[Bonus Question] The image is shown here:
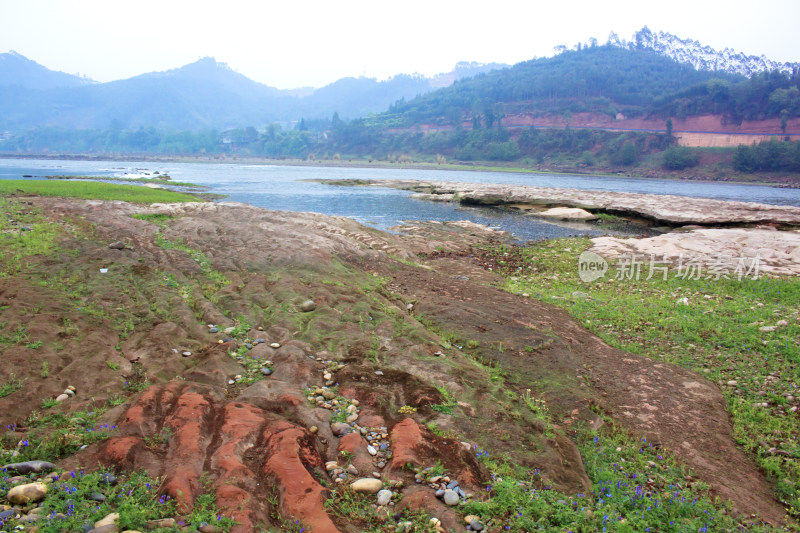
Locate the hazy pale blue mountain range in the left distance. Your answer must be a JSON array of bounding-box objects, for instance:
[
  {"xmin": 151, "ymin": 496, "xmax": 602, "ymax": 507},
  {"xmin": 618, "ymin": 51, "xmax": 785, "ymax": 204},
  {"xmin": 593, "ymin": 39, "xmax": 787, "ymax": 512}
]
[{"xmin": 0, "ymin": 52, "xmax": 510, "ymax": 131}]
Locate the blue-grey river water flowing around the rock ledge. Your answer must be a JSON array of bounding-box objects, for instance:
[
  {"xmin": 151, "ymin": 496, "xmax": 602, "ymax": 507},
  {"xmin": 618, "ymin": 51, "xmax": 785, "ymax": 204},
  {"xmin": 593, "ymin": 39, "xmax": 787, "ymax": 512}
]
[{"xmin": 0, "ymin": 159, "xmax": 800, "ymax": 240}]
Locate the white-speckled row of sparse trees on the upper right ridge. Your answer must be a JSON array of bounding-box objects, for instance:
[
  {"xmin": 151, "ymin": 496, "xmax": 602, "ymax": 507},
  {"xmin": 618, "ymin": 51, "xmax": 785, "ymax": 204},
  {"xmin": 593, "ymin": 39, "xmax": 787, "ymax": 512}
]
[{"xmin": 608, "ymin": 26, "xmax": 800, "ymax": 78}]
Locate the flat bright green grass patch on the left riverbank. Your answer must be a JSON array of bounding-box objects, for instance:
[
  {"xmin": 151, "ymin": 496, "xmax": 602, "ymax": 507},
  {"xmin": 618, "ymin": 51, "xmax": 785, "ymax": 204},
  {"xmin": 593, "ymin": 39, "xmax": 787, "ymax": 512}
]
[{"xmin": 0, "ymin": 180, "xmax": 199, "ymax": 204}]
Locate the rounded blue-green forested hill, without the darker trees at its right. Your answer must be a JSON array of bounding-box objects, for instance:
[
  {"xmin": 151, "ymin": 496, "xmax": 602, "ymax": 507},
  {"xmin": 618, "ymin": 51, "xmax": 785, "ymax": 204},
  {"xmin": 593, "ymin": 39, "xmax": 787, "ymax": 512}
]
[{"xmin": 382, "ymin": 45, "xmax": 746, "ymax": 126}]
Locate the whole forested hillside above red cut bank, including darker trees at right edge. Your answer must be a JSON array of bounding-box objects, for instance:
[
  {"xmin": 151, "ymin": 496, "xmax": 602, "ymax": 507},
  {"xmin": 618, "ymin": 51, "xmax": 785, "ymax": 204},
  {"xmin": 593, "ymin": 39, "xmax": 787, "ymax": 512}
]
[{"xmin": 373, "ymin": 45, "xmax": 800, "ymax": 127}]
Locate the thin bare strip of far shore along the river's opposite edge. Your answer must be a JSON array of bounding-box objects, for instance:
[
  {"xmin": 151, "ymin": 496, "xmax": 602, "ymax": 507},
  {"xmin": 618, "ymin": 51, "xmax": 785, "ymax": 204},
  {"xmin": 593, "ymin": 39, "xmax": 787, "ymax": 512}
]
[{"xmin": 0, "ymin": 153, "xmax": 800, "ymax": 189}]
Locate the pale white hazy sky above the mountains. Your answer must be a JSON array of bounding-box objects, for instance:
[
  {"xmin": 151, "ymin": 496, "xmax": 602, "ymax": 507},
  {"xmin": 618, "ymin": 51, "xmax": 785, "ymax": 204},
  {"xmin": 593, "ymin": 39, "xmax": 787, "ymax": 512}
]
[{"xmin": 0, "ymin": 0, "xmax": 800, "ymax": 88}]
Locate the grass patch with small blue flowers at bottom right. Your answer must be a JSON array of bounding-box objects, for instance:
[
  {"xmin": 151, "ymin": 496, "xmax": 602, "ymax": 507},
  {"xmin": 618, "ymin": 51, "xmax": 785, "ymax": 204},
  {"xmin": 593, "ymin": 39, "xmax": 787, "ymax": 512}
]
[{"xmin": 459, "ymin": 426, "xmax": 768, "ymax": 533}]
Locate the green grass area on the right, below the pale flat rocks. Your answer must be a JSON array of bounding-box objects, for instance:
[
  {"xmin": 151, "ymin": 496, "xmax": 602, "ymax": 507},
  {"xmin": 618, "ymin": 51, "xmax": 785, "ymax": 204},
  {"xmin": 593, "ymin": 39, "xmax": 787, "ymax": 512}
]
[{"xmin": 482, "ymin": 239, "xmax": 800, "ymax": 516}]
